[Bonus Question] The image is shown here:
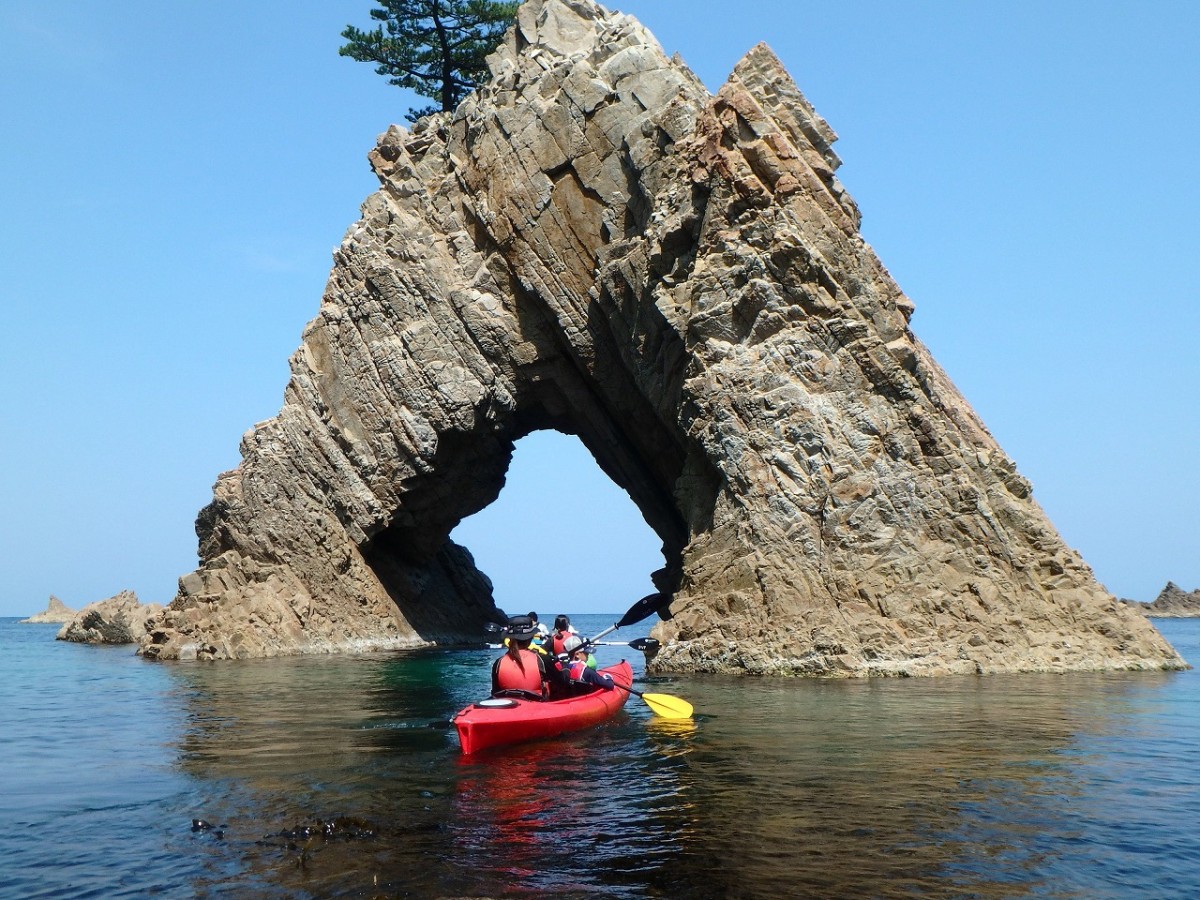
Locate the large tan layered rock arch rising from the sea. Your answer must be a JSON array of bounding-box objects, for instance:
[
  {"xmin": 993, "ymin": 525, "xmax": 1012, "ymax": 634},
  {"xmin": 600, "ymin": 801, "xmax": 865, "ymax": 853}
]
[{"xmin": 133, "ymin": 0, "xmax": 1184, "ymax": 676}]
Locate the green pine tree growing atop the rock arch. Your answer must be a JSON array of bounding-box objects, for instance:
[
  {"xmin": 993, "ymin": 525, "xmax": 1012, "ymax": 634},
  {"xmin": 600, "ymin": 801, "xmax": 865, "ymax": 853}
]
[{"xmin": 338, "ymin": 0, "xmax": 520, "ymax": 122}]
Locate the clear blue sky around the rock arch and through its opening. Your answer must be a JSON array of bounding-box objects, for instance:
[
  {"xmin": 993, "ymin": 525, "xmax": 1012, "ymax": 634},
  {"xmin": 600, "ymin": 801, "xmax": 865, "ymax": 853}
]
[{"xmin": 0, "ymin": 0, "xmax": 1200, "ymax": 616}]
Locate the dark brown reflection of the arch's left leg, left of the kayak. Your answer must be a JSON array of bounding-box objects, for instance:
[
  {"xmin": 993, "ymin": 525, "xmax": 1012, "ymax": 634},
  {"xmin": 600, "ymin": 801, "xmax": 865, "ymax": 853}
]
[{"xmin": 172, "ymin": 652, "xmax": 468, "ymax": 896}]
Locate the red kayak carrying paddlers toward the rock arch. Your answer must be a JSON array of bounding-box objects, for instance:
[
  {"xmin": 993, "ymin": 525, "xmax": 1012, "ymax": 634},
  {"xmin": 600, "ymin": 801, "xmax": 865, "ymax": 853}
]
[{"xmin": 454, "ymin": 660, "xmax": 634, "ymax": 754}]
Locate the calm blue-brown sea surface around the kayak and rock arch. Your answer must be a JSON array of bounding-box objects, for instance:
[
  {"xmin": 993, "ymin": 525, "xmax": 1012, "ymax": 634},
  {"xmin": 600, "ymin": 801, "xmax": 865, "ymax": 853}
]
[{"xmin": 0, "ymin": 612, "xmax": 1200, "ymax": 899}]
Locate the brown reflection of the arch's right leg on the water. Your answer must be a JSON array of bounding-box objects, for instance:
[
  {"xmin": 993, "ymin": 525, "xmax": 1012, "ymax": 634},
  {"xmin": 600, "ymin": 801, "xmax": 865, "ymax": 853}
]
[{"xmin": 633, "ymin": 673, "xmax": 1171, "ymax": 896}]
